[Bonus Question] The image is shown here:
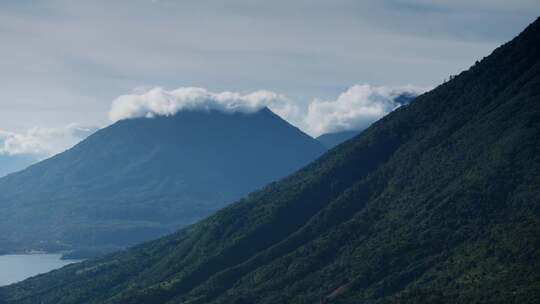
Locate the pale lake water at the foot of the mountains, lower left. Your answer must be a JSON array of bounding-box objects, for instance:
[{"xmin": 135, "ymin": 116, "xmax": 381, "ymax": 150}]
[{"xmin": 0, "ymin": 253, "xmax": 77, "ymax": 286}]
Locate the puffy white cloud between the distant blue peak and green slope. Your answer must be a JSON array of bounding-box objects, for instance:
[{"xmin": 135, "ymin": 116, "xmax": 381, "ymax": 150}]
[{"xmin": 305, "ymin": 84, "xmax": 425, "ymax": 136}]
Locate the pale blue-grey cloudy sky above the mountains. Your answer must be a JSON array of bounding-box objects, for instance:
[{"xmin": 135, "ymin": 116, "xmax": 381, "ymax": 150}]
[{"xmin": 0, "ymin": 0, "xmax": 540, "ymax": 155}]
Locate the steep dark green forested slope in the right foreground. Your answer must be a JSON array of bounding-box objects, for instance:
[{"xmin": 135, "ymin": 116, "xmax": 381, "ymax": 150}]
[{"xmin": 0, "ymin": 20, "xmax": 540, "ymax": 304}]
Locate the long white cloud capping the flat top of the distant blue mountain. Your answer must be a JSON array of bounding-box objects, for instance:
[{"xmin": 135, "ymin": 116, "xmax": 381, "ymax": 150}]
[{"xmin": 109, "ymin": 87, "xmax": 295, "ymax": 122}]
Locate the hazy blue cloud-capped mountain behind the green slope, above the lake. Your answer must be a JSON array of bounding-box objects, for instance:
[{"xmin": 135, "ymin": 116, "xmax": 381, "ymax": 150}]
[{"xmin": 0, "ymin": 108, "xmax": 325, "ymax": 251}]
